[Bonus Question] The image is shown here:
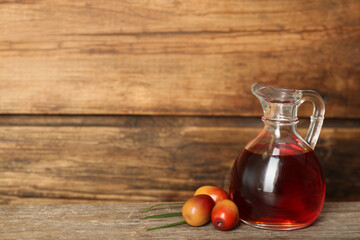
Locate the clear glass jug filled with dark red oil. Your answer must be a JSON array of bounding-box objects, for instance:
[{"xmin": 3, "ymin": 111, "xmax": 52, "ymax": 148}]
[{"xmin": 229, "ymin": 83, "xmax": 325, "ymax": 230}]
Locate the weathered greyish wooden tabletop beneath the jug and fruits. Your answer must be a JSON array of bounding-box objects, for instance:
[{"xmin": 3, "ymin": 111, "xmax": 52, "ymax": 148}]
[{"xmin": 0, "ymin": 202, "xmax": 360, "ymax": 239}]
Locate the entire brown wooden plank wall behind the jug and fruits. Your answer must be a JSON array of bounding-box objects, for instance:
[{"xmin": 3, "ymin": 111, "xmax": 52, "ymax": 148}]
[{"xmin": 0, "ymin": 0, "xmax": 360, "ymax": 204}]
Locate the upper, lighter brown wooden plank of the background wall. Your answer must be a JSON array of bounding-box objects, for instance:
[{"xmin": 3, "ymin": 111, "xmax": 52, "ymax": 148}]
[{"xmin": 0, "ymin": 0, "xmax": 360, "ymax": 118}]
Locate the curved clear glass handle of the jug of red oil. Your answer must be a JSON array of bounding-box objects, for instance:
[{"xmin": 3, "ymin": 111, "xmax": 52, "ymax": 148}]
[{"xmin": 300, "ymin": 90, "xmax": 325, "ymax": 149}]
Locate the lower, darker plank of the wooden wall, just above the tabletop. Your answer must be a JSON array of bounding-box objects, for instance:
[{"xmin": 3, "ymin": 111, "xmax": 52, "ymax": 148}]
[{"xmin": 0, "ymin": 116, "xmax": 360, "ymax": 204}]
